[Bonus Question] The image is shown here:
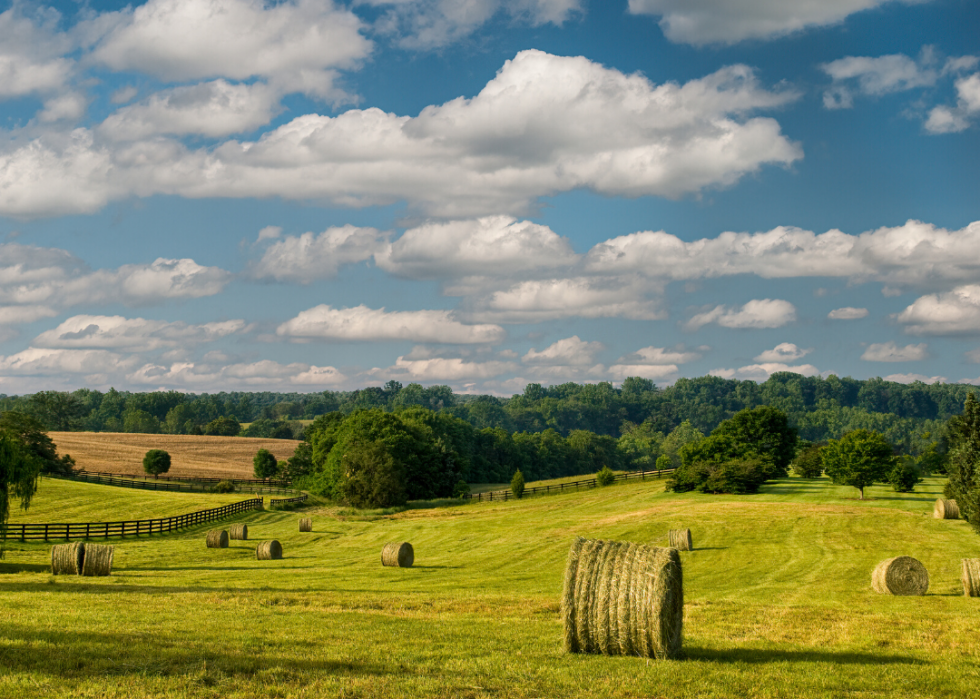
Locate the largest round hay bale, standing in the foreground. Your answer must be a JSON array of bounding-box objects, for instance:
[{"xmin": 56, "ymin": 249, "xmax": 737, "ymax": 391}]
[{"xmin": 561, "ymin": 537, "xmax": 684, "ymax": 658}]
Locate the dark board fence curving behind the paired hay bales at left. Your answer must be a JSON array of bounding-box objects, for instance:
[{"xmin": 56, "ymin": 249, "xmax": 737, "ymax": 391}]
[{"xmin": 4, "ymin": 498, "xmax": 262, "ymax": 541}]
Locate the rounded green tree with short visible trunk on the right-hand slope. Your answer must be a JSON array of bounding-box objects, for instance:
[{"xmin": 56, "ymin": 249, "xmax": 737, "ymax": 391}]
[{"xmin": 820, "ymin": 430, "xmax": 898, "ymax": 500}]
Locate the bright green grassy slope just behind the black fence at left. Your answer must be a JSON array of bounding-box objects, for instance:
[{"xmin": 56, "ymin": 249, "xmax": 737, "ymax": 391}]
[{"xmin": 10, "ymin": 478, "xmax": 249, "ymax": 524}]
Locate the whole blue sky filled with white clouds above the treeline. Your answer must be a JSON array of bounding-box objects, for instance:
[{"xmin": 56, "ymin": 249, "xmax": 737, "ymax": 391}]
[{"xmin": 0, "ymin": 0, "xmax": 980, "ymax": 395}]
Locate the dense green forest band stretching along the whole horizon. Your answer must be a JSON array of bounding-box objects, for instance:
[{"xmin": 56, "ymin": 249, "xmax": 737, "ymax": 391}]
[{"xmin": 0, "ymin": 373, "xmax": 978, "ymax": 452}]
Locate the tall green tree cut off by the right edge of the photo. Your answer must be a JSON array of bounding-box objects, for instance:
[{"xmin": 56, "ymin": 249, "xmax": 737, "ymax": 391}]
[{"xmin": 944, "ymin": 393, "xmax": 980, "ymax": 531}]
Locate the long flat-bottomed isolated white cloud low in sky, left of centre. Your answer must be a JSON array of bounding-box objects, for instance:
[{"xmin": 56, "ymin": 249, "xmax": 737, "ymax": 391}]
[{"xmin": 276, "ymin": 304, "xmax": 506, "ymax": 344}]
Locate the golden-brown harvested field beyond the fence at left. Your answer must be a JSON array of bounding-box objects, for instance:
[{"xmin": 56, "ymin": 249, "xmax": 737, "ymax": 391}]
[{"xmin": 48, "ymin": 432, "xmax": 299, "ymax": 478}]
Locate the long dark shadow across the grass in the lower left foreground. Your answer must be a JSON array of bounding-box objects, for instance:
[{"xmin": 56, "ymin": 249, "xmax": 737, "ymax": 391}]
[{"xmin": 3, "ymin": 625, "xmax": 394, "ymax": 680}]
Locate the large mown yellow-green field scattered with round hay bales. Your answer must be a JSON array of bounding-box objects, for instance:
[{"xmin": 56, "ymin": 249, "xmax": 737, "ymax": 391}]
[{"xmin": 0, "ymin": 478, "xmax": 980, "ymax": 698}]
